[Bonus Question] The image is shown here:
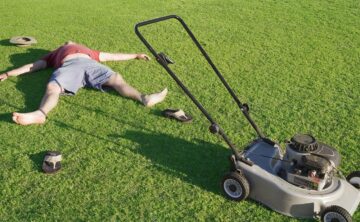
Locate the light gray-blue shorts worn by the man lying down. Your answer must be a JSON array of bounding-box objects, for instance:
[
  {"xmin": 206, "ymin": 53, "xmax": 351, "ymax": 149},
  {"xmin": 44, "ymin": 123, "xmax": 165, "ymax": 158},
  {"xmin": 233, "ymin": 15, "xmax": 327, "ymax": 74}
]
[{"xmin": 49, "ymin": 58, "xmax": 115, "ymax": 94}]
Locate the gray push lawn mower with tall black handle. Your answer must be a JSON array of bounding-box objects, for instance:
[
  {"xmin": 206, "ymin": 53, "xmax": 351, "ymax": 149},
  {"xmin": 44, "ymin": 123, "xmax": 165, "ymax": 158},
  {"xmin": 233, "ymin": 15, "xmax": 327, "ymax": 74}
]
[{"xmin": 135, "ymin": 15, "xmax": 360, "ymax": 222}]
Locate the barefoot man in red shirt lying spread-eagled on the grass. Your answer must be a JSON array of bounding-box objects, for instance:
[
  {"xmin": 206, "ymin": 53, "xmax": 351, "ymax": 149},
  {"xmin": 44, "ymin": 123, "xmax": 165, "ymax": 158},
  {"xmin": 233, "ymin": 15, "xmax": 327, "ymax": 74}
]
[{"xmin": 0, "ymin": 41, "xmax": 167, "ymax": 125}]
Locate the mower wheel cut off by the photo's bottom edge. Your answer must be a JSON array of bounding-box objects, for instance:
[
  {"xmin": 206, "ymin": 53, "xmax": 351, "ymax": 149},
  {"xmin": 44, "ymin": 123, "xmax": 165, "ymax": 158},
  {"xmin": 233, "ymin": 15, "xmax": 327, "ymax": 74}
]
[{"xmin": 321, "ymin": 206, "xmax": 352, "ymax": 222}]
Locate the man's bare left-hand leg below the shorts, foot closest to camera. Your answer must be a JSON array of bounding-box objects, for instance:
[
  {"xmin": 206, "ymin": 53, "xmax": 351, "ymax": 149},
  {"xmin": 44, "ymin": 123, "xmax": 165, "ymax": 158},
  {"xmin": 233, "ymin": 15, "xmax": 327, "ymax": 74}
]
[{"xmin": 12, "ymin": 81, "xmax": 63, "ymax": 125}]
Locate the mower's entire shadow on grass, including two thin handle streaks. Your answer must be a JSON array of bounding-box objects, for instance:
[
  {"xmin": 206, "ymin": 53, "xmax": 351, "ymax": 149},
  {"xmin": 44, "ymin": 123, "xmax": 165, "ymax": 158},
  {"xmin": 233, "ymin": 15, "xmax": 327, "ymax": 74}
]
[{"xmin": 50, "ymin": 93, "xmax": 230, "ymax": 195}]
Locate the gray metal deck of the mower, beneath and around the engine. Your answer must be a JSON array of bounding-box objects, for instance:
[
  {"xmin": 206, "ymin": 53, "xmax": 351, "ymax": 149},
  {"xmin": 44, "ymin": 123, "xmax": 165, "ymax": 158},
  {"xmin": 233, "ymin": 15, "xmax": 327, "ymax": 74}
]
[{"xmin": 236, "ymin": 140, "xmax": 360, "ymax": 218}]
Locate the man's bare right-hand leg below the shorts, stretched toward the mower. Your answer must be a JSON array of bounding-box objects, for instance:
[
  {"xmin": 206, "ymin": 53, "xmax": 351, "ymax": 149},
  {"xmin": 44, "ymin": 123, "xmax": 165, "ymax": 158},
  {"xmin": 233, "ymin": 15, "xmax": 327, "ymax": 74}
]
[{"xmin": 104, "ymin": 73, "xmax": 168, "ymax": 107}]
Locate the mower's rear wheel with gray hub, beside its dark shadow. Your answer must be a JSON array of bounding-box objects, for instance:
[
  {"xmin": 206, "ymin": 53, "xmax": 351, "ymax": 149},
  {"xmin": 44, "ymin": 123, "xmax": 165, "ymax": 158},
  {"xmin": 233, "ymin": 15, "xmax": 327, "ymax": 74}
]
[{"xmin": 222, "ymin": 171, "xmax": 250, "ymax": 201}]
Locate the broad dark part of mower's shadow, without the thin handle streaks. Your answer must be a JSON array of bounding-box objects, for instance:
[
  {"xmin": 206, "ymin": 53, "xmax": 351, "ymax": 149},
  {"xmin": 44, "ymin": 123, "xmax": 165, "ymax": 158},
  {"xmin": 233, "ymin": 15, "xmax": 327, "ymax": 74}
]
[{"xmin": 122, "ymin": 131, "xmax": 230, "ymax": 194}]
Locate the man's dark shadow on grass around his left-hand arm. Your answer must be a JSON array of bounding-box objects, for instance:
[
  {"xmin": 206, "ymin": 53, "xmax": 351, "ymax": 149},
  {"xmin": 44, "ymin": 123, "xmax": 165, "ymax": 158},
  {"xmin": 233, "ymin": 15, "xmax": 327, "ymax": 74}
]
[{"xmin": 4, "ymin": 48, "xmax": 52, "ymax": 112}]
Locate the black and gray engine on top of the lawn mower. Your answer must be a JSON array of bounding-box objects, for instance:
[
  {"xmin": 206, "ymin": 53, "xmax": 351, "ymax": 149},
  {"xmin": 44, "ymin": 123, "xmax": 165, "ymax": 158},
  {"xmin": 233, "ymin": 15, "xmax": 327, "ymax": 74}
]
[{"xmin": 282, "ymin": 134, "xmax": 340, "ymax": 191}]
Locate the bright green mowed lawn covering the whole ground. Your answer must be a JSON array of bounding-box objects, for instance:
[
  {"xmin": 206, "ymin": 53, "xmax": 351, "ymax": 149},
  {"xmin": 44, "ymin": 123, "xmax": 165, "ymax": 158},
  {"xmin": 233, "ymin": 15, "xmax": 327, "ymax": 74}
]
[{"xmin": 0, "ymin": 0, "xmax": 360, "ymax": 221}]
